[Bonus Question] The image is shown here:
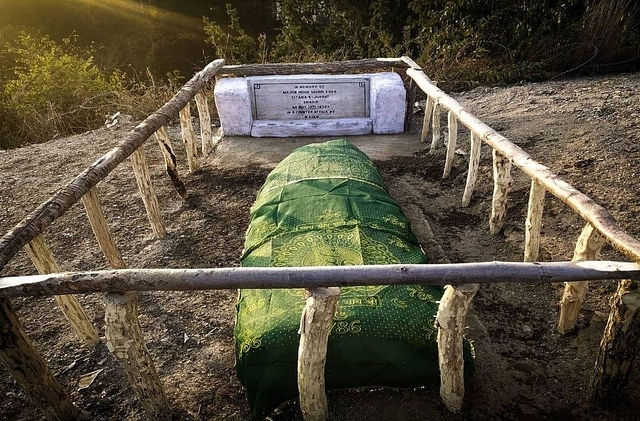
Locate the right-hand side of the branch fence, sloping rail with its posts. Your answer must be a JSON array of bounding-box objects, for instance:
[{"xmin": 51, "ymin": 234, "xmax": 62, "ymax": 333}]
[{"xmin": 406, "ymin": 66, "xmax": 640, "ymax": 410}]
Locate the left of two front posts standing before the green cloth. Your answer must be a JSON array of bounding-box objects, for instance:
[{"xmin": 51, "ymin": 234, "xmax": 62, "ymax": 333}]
[{"xmin": 298, "ymin": 287, "xmax": 340, "ymax": 421}]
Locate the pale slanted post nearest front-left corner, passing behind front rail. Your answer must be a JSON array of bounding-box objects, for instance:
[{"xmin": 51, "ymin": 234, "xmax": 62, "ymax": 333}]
[{"xmin": 24, "ymin": 234, "xmax": 100, "ymax": 346}]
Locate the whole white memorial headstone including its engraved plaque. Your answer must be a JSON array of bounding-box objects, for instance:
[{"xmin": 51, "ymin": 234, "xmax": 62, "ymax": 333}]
[{"xmin": 214, "ymin": 72, "xmax": 406, "ymax": 137}]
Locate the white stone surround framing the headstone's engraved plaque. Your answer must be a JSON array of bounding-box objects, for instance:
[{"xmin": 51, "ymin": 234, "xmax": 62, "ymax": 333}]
[{"xmin": 214, "ymin": 72, "xmax": 406, "ymax": 137}]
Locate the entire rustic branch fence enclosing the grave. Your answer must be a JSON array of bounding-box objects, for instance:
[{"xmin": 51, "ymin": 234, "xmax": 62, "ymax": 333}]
[{"xmin": 0, "ymin": 57, "xmax": 640, "ymax": 420}]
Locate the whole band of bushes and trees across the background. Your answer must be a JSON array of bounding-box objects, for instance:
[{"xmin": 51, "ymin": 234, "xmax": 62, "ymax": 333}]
[{"xmin": 0, "ymin": 0, "xmax": 640, "ymax": 148}]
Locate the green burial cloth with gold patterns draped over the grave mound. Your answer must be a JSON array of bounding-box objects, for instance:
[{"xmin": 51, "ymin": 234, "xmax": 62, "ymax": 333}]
[{"xmin": 235, "ymin": 139, "xmax": 472, "ymax": 418}]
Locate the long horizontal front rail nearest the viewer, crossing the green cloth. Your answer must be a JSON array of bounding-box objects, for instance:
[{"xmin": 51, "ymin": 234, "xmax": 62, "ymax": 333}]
[{"xmin": 0, "ymin": 261, "xmax": 640, "ymax": 297}]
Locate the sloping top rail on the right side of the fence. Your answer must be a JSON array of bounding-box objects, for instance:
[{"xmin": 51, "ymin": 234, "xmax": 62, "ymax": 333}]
[{"xmin": 407, "ymin": 69, "xmax": 640, "ymax": 262}]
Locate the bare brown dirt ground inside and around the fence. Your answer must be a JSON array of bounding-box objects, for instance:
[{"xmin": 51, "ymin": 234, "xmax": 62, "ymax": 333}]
[{"xmin": 0, "ymin": 74, "xmax": 640, "ymax": 421}]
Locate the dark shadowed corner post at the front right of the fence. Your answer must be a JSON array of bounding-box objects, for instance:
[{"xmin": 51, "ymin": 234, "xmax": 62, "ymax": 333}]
[{"xmin": 589, "ymin": 280, "xmax": 640, "ymax": 406}]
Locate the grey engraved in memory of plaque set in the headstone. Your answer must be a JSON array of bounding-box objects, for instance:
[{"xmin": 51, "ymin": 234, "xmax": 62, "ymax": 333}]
[{"xmin": 249, "ymin": 77, "xmax": 369, "ymax": 120}]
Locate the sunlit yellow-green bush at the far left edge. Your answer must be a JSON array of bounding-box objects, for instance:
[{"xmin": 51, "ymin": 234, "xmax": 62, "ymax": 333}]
[{"xmin": 0, "ymin": 32, "xmax": 123, "ymax": 147}]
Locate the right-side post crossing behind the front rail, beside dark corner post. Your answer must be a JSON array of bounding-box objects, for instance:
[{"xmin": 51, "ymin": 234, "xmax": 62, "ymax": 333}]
[{"xmin": 558, "ymin": 224, "xmax": 605, "ymax": 334}]
